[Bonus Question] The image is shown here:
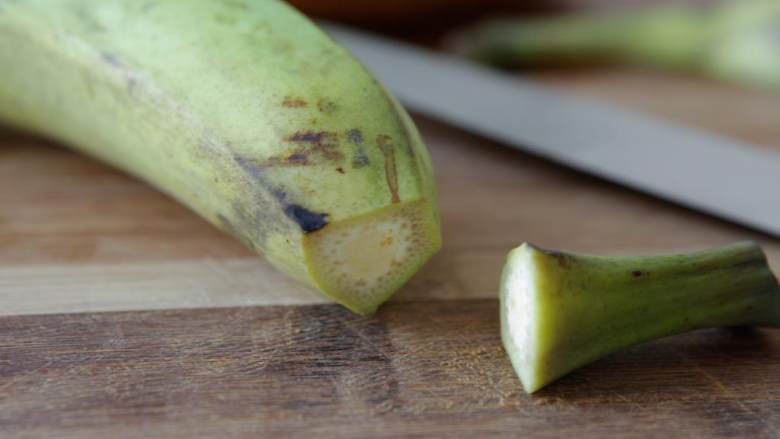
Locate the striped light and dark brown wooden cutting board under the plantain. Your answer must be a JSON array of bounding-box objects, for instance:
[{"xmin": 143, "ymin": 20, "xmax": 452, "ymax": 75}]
[{"xmin": 0, "ymin": 72, "xmax": 780, "ymax": 438}]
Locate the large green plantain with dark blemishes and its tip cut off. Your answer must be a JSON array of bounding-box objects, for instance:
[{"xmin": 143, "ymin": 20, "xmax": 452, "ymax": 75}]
[{"xmin": 0, "ymin": 0, "xmax": 441, "ymax": 314}]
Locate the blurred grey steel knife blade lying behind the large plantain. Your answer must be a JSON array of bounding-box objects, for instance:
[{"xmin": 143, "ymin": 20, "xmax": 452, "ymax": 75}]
[{"xmin": 323, "ymin": 23, "xmax": 780, "ymax": 236}]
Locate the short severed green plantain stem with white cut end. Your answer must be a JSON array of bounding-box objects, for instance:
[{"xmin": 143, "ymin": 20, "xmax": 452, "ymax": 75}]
[{"xmin": 501, "ymin": 242, "xmax": 780, "ymax": 393}]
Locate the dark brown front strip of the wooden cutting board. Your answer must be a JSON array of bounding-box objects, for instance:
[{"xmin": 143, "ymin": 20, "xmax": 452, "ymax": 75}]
[{"xmin": 0, "ymin": 300, "xmax": 780, "ymax": 439}]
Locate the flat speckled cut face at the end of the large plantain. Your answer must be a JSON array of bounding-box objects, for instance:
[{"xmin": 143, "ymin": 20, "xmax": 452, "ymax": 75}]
[{"xmin": 305, "ymin": 200, "xmax": 441, "ymax": 314}]
